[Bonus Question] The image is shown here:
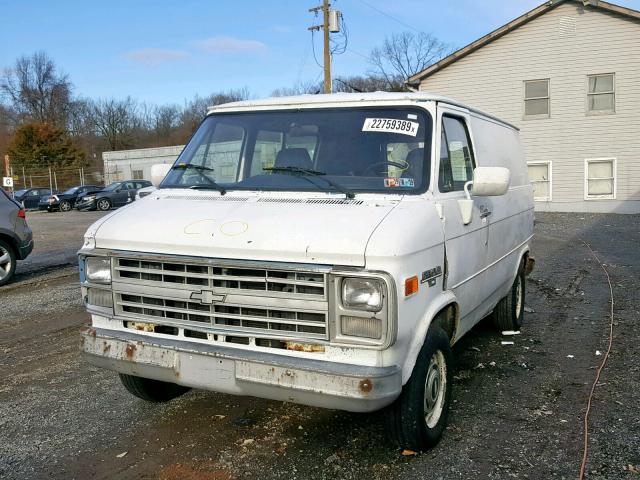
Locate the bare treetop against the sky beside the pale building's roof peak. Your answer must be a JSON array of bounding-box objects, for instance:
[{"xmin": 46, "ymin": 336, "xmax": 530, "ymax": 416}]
[{"xmin": 369, "ymin": 32, "xmax": 451, "ymax": 91}]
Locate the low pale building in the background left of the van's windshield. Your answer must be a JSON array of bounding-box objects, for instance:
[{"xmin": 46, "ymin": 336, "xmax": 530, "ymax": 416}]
[{"xmin": 102, "ymin": 145, "xmax": 184, "ymax": 185}]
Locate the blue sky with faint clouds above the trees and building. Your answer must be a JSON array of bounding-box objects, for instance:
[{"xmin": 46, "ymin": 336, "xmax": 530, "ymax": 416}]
[{"xmin": 0, "ymin": 0, "xmax": 640, "ymax": 104}]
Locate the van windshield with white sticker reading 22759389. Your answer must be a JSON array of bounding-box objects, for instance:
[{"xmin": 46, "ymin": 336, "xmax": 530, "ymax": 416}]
[{"xmin": 161, "ymin": 107, "xmax": 431, "ymax": 194}]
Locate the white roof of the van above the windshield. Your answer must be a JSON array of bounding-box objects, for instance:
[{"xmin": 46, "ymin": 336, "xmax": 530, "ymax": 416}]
[{"xmin": 207, "ymin": 92, "xmax": 519, "ymax": 130}]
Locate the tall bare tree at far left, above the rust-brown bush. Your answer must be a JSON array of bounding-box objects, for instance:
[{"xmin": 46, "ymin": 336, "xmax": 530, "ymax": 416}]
[{"xmin": 0, "ymin": 51, "xmax": 72, "ymax": 128}]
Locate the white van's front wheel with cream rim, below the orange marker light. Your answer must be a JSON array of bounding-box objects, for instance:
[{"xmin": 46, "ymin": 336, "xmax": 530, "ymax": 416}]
[{"xmin": 385, "ymin": 326, "xmax": 453, "ymax": 451}]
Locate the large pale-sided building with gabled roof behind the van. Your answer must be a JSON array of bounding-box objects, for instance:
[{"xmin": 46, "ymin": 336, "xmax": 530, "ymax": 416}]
[{"xmin": 408, "ymin": 0, "xmax": 640, "ymax": 213}]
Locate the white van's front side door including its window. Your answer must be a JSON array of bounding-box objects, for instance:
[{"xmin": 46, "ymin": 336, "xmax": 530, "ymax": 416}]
[{"xmin": 434, "ymin": 104, "xmax": 490, "ymax": 337}]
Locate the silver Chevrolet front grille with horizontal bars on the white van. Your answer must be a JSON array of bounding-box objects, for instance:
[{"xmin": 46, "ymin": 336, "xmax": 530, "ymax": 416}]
[{"xmin": 113, "ymin": 258, "xmax": 329, "ymax": 346}]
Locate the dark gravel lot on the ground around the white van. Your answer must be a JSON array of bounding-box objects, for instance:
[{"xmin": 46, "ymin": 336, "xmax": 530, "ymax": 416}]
[{"xmin": 0, "ymin": 212, "xmax": 640, "ymax": 480}]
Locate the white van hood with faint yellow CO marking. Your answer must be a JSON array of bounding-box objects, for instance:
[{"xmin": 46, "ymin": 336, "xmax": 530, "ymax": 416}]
[{"xmin": 87, "ymin": 192, "xmax": 399, "ymax": 267}]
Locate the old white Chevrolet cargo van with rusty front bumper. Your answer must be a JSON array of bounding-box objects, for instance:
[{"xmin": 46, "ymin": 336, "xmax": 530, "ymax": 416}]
[{"xmin": 79, "ymin": 93, "xmax": 533, "ymax": 450}]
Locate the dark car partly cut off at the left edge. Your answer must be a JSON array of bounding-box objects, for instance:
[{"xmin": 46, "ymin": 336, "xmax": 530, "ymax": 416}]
[{"xmin": 0, "ymin": 189, "xmax": 33, "ymax": 285}]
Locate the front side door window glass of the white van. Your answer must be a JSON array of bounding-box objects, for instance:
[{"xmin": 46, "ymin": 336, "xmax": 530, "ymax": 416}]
[{"xmin": 438, "ymin": 117, "xmax": 475, "ymax": 192}]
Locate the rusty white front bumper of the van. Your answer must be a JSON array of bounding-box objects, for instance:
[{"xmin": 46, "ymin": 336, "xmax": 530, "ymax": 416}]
[{"xmin": 81, "ymin": 327, "xmax": 402, "ymax": 412}]
